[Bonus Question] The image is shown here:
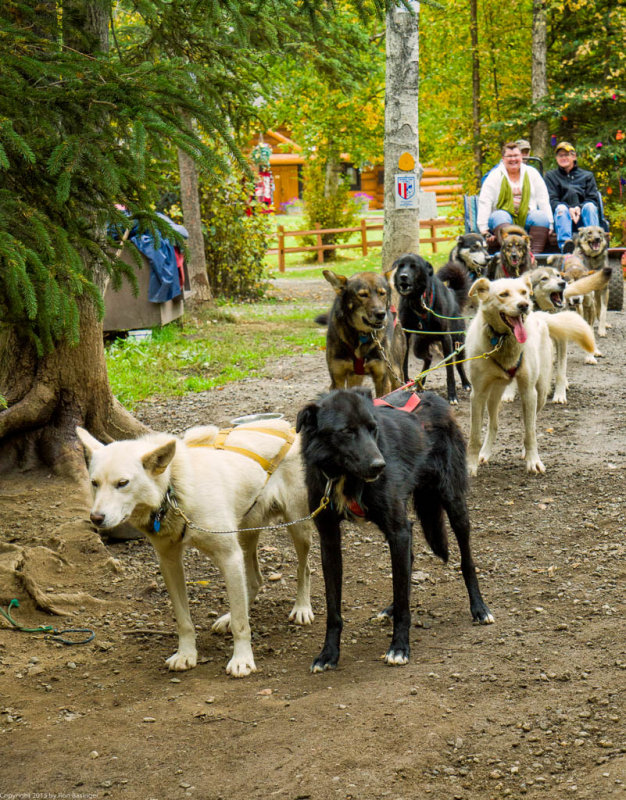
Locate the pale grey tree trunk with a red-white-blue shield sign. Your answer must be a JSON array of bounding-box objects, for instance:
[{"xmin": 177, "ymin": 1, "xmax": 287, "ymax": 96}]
[{"xmin": 382, "ymin": 3, "xmax": 422, "ymax": 272}]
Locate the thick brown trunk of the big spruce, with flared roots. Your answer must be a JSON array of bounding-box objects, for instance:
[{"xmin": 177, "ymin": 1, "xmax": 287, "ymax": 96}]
[{"xmin": 0, "ymin": 0, "xmax": 146, "ymax": 477}]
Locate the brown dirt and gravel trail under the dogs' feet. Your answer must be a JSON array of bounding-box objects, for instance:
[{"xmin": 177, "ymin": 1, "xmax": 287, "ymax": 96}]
[{"xmin": 0, "ymin": 287, "xmax": 626, "ymax": 800}]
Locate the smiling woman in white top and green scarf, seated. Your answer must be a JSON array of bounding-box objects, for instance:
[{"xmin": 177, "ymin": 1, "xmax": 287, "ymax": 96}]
[{"xmin": 477, "ymin": 142, "xmax": 554, "ymax": 253}]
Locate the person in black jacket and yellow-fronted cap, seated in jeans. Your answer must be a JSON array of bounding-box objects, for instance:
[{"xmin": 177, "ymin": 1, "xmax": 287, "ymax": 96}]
[{"xmin": 545, "ymin": 142, "xmax": 600, "ymax": 253}]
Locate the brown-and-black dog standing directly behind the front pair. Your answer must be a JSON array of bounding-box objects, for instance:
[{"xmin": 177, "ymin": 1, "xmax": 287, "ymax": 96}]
[{"xmin": 318, "ymin": 269, "xmax": 406, "ymax": 397}]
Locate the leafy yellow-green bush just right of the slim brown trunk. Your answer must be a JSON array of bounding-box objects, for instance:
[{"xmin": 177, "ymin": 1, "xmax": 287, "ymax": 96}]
[{"xmin": 200, "ymin": 172, "xmax": 270, "ymax": 300}]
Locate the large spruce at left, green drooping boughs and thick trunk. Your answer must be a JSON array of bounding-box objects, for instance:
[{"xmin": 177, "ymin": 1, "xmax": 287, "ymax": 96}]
[{"xmin": 0, "ymin": 0, "xmax": 388, "ymax": 474}]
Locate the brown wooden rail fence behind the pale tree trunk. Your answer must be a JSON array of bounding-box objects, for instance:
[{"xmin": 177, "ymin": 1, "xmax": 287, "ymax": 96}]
[{"xmin": 266, "ymin": 218, "xmax": 460, "ymax": 272}]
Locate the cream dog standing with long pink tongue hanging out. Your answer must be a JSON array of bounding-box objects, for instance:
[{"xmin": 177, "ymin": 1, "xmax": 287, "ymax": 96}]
[{"xmin": 466, "ymin": 274, "xmax": 593, "ymax": 475}]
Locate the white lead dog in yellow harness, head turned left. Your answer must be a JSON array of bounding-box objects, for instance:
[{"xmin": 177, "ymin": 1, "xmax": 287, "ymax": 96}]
[{"xmin": 76, "ymin": 420, "xmax": 313, "ymax": 677}]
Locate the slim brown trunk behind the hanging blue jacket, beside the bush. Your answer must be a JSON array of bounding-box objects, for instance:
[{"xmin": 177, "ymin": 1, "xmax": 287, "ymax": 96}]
[{"xmin": 178, "ymin": 142, "xmax": 213, "ymax": 302}]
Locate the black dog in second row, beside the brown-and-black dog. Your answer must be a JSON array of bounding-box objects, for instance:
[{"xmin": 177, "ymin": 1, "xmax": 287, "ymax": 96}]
[{"xmin": 393, "ymin": 253, "xmax": 470, "ymax": 405}]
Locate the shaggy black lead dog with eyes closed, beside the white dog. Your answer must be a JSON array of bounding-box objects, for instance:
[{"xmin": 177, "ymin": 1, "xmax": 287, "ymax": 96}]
[{"xmin": 296, "ymin": 389, "xmax": 494, "ymax": 672}]
